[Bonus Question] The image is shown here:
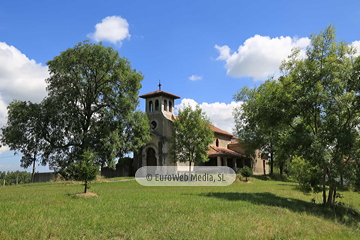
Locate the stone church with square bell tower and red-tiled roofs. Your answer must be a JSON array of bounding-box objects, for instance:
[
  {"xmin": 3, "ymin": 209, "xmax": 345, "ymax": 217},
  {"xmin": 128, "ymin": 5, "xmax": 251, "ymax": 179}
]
[{"xmin": 134, "ymin": 88, "xmax": 268, "ymax": 174}]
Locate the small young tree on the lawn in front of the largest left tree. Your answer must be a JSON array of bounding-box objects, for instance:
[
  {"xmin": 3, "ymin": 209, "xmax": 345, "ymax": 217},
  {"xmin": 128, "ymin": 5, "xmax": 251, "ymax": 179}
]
[{"xmin": 75, "ymin": 150, "xmax": 99, "ymax": 193}]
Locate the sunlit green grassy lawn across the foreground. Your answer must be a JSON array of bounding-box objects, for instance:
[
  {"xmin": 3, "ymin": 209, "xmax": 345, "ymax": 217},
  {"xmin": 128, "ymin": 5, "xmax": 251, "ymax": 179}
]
[{"xmin": 0, "ymin": 175, "xmax": 360, "ymax": 239}]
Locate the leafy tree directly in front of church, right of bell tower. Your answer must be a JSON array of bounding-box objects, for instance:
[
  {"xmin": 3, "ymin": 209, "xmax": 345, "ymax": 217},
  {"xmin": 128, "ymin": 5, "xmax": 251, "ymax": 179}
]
[{"xmin": 170, "ymin": 105, "xmax": 214, "ymax": 172}]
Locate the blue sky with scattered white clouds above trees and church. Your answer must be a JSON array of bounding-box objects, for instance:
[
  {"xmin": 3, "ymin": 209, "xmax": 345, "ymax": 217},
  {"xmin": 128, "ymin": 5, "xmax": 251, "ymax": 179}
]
[{"xmin": 0, "ymin": 0, "xmax": 360, "ymax": 171}]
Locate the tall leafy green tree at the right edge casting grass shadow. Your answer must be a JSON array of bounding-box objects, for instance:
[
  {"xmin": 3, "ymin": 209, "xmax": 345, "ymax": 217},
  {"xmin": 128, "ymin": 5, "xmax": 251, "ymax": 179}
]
[{"xmin": 279, "ymin": 25, "xmax": 360, "ymax": 206}]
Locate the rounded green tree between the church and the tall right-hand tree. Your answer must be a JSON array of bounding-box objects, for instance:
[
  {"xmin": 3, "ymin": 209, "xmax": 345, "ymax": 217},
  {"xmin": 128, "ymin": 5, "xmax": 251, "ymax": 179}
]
[{"xmin": 234, "ymin": 78, "xmax": 289, "ymax": 174}]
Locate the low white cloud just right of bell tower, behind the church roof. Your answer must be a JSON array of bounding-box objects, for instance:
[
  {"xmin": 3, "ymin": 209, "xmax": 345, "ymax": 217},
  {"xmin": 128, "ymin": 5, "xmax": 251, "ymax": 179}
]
[{"xmin": 175, "ymin": 98, "xmax": 241, "ymax": 133}]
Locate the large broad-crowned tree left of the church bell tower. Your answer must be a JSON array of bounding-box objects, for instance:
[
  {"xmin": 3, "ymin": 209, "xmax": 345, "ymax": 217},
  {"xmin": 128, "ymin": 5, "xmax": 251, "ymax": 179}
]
[{"xmin": 1, "ymin": 41, "xmax": 150, "ymax": 176}]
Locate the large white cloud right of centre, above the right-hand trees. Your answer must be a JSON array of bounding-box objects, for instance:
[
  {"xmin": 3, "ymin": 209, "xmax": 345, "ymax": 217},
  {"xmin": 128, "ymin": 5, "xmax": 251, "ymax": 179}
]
[{"xmin": 215, "ymin": 35, "xmax": 310, "ymax": 81}]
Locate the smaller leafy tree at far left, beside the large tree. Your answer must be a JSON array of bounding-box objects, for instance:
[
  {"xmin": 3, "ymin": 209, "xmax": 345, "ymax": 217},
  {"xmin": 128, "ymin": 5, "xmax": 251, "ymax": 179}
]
[{"xmin": 0, "ymin": 100, "xmax": 46, "ymax": 182}]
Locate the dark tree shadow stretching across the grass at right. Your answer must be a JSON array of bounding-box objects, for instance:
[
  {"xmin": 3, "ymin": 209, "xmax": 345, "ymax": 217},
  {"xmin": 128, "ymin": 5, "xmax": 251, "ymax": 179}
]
[{"xmin": 198, "ymin": 192, "xmax": 360, "ymax": 227}]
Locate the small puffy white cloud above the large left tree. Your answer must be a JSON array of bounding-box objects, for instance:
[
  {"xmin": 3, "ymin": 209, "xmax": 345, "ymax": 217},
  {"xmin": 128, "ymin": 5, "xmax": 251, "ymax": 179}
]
[{"xmin": 87, "ymin": 16, "xmax": 131, "ymax": 46}]
